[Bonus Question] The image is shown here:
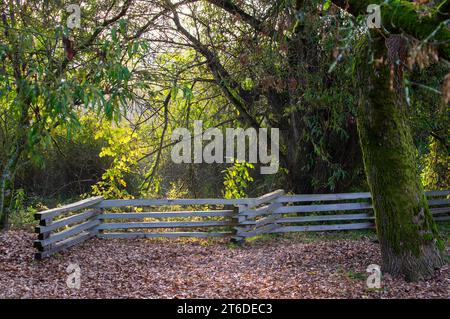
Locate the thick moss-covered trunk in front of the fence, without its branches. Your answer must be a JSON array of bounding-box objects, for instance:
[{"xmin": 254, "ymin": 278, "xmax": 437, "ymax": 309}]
[{"xmin": 357, "ymin": 33, "xmax": 444, "ymax": 281}]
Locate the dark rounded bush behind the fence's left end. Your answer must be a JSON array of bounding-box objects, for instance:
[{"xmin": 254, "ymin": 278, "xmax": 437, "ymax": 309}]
[{"xmin": 16, "ymin": 115, "xmax": 111, "ymax": 199}]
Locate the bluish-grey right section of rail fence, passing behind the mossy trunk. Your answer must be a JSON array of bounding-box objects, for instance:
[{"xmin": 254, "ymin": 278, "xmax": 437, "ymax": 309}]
[{"xmin": 234, "ymin": 190, "xmax": 450, "ymax": 241}]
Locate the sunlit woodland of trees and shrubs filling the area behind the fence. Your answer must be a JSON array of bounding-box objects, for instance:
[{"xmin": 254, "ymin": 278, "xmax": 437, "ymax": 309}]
[{"xmin": 0, "ymin": 0, "xmax": 450, "ymax": 228}]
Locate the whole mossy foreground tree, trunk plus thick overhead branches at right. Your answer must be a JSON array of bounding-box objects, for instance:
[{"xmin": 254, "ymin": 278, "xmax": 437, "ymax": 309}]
[{"xmin": 328, "ymin": 0, "xmax": 450, "ymax": 280}]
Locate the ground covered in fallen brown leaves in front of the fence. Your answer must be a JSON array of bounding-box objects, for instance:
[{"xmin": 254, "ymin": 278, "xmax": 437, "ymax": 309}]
[{"xmin": 0, "ymin": 231, "xmax": 450, "ymax": 299}]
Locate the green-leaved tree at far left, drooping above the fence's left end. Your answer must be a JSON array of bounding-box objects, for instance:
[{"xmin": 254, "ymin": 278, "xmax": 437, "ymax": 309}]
[{"xmin": 0, "ymin": 1, "xmax": 146, "ymax": 227}]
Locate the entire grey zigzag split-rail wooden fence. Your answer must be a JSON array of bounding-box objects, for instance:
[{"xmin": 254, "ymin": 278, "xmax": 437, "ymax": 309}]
[{"xmin": 34, "ymin": 190, "xmax": 450, "ymax": 259}]
